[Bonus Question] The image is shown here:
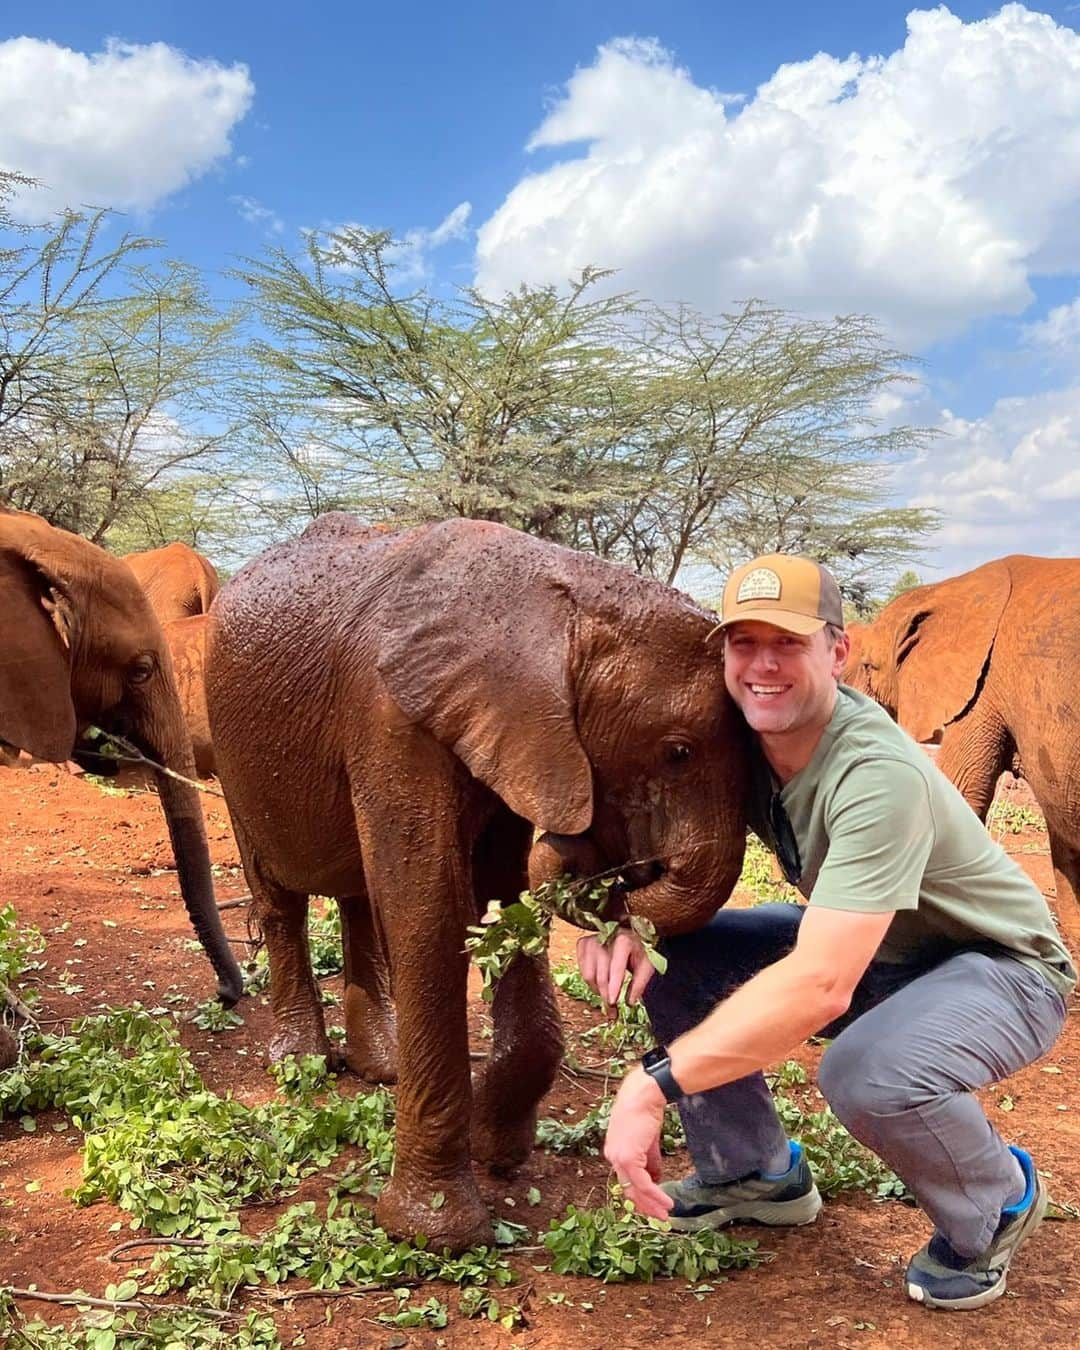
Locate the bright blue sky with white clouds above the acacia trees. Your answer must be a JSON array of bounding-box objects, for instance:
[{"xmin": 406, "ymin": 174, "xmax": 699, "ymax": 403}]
[{"xmin": 0, "ymin": 0, "xmax": 1080, "ymax": 576}]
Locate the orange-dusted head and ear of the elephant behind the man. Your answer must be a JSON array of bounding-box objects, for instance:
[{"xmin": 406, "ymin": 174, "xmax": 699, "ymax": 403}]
[{"xmin": 844, "ymin": 562, "xmax": 1011, "ymax": 741}]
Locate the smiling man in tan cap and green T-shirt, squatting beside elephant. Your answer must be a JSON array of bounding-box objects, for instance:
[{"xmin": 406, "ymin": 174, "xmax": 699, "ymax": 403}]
[{"xmin": 578, "ymin": 555, "xmax": 1076, "ymax": 1308}]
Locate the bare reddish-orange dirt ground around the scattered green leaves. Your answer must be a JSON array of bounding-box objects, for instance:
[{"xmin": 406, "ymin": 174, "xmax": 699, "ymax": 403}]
[{"xmin": 0, "ymin": 765, "xmax": 1080, "ymax": 1350}]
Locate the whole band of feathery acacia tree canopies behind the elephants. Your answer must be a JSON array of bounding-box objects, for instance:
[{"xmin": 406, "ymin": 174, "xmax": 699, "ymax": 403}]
[{"xmin": 0, "ymin": 190, "xmax": 934, "ymax": 591}]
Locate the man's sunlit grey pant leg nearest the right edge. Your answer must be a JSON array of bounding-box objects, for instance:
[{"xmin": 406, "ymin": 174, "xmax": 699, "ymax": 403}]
[{"xmin": 818, "ymin": 952, "xmax": 1065, "ymax": 1257}]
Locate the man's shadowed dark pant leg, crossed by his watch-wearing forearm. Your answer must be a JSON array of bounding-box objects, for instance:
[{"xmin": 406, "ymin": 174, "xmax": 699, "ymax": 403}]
[{"xmin": 644, "ymin": 905, "xmax": 803, "ymax": 1184}]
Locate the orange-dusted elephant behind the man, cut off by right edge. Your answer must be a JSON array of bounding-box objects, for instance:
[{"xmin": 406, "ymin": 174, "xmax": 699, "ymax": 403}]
[{"xmin": 844, "ymin": 554, "xmax": 1080, "ymax": 934}]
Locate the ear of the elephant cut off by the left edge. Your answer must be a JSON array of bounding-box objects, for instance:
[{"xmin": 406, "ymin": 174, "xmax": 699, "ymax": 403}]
[{"xmin": 0, "ymin": 536, "xmax": 76, "ymax": 763}]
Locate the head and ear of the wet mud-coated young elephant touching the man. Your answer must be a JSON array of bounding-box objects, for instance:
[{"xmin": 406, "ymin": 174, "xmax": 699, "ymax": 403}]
[{"xmin": 379, "ymin": 521, "xmax": 745, "ymax": 933}]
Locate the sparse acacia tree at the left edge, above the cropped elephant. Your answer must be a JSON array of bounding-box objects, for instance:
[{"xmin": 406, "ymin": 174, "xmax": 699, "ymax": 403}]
[{"xmin": 0, "ymin": 212, "xmax": 235, "ymax": 547}]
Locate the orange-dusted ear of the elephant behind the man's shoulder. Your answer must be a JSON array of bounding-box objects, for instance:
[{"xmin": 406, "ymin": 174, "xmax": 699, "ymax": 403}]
[{"xmin": 895, "ymin": 562, "xmax": 1013, "ymax": 741}]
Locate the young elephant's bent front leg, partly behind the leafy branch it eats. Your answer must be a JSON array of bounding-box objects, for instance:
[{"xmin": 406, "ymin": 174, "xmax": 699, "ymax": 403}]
[{"xmin": 473, "ymin": 811, "xmax": 563, "ymax": 1175}]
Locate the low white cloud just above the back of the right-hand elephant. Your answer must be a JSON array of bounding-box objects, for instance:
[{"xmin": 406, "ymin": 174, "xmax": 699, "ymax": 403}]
[{"xmin": 895, "ymin": 385, "xmax": 1080, "ymax": 575}]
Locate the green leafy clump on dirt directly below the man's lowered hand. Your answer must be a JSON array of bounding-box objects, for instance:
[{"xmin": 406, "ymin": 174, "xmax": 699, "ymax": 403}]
[{"xmin": 543, "ymin": 1199, "xmax": 771, "ymax": 1284}]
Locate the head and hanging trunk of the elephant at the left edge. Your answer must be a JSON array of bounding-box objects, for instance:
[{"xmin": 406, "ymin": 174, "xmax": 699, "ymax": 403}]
[{"xmin": 0, "ymin": 510, "xmax": 243, "ymax": 1003}]
